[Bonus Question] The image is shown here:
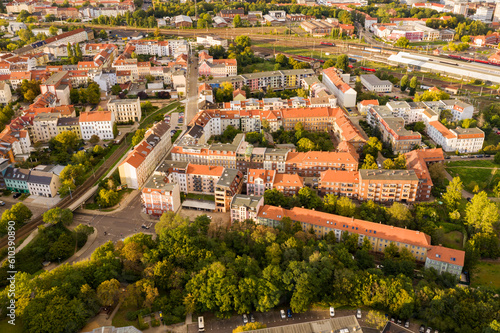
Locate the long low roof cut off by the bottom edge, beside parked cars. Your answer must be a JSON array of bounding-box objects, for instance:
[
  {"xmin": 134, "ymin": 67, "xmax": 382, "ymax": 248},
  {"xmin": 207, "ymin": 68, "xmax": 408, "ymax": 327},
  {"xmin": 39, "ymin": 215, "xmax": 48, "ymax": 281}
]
[{"xmin": 252, "ymin": 316, "xmax": 363, "ymax": 333}]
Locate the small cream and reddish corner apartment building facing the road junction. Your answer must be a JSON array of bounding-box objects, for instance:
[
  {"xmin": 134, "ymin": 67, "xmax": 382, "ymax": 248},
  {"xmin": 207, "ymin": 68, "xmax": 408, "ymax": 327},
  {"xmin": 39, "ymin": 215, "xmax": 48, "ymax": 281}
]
[{"xmin": 141, "ymin": 176, "xmax": 181, "ymax": 217}]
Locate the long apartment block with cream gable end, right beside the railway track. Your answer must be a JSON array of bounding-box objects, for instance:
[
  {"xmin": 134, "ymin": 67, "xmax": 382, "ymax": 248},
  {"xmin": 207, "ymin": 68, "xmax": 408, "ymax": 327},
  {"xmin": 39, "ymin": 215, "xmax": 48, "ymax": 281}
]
[{"xmin": 118, "ymin": 121, "xmax": 172, "ymax": 189}]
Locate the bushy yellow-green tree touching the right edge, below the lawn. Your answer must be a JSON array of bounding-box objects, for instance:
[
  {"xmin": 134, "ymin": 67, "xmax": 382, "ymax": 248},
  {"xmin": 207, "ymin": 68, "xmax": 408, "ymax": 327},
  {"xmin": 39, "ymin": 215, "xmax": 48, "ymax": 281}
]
[{"xmin": 465, "ymin": 191, "xmax": 499, "ymax": 234}]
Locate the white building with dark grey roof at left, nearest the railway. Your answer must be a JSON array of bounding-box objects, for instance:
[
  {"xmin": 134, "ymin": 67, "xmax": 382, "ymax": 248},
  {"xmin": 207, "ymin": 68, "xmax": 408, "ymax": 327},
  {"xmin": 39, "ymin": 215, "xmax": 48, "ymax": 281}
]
[{"xmin": 28, "ymin": 165, "xmax": 62, "ymax": 198}]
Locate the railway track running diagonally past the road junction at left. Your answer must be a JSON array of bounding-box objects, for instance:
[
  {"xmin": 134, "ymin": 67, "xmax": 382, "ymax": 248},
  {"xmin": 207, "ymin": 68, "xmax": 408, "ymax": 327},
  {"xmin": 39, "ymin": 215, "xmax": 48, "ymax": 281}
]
[{"xmin": 0, "ymin": 142, "xmax": 129, "ymax": 248}]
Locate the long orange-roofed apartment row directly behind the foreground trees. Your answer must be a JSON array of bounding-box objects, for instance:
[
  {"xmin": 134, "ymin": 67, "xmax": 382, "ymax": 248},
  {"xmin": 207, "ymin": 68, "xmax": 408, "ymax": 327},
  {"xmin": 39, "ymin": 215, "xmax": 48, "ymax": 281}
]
[{"xmin": 257, "ymin": 205, "xmax": 465, "ymax": 276}]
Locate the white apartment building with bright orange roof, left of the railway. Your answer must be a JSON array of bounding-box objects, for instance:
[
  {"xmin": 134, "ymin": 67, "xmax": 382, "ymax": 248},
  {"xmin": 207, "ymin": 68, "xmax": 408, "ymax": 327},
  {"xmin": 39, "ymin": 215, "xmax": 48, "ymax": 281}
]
[{"xmin": 79, "ymin": 111, "xmax": 115, "ymax": 140}]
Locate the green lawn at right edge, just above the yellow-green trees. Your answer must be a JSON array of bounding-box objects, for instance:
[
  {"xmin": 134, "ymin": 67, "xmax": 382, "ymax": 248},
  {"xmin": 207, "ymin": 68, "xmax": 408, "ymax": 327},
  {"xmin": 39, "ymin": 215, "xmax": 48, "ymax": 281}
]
[{"xmin": 446, "ymin": 166, "xmax": 500, "ymax": 196}]
